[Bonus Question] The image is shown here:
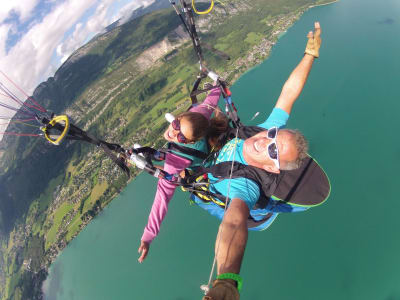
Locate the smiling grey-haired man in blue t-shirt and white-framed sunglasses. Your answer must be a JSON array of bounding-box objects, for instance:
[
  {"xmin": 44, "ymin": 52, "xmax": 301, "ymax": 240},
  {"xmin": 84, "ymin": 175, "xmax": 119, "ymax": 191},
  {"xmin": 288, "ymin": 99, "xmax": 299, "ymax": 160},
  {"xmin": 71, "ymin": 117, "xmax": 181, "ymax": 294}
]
[{"xmin": 198, "ymin": 22, "xmax": 321, "ymax": 300}]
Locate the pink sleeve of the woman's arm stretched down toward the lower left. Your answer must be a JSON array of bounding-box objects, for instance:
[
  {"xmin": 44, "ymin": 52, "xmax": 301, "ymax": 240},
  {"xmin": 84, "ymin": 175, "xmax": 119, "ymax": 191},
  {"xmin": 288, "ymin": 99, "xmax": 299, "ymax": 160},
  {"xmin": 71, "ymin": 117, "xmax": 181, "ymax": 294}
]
[{"xmin": 142, "ymin": 153, "xmax": 191, "ymax": 243}]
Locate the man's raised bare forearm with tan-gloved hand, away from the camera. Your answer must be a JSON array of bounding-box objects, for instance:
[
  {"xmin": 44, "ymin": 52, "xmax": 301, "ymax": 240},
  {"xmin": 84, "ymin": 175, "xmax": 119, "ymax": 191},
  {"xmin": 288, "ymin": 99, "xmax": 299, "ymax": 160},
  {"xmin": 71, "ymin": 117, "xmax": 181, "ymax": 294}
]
[{"xmin": 275, "ymin": 22, "xmax": 321, "ymax": 114}]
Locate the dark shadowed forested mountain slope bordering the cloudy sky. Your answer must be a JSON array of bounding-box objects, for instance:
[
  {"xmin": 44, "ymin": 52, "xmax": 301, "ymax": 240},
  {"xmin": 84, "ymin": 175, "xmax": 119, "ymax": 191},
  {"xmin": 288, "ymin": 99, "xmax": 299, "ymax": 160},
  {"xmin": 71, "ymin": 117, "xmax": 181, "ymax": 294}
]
[{"xmin": 0, "ymin": 5, "xmax": 179, "ymax": 232}]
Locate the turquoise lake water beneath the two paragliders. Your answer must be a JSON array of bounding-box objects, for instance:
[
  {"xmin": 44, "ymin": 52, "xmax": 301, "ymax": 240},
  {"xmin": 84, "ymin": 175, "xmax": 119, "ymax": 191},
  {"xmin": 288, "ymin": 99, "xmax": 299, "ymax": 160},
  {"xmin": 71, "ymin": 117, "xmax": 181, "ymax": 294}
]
[{"xmin": 44, "ymin": 0, "xmax": 400, "ymax": 300}]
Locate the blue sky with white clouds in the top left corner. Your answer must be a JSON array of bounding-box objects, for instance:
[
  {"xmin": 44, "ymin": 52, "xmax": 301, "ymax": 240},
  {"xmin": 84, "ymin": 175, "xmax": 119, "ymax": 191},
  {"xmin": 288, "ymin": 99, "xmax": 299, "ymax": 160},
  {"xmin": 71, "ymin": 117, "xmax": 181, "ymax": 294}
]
[{"xmin": 0, "ymin": 0, "xmax": 154, "ymax": 140}]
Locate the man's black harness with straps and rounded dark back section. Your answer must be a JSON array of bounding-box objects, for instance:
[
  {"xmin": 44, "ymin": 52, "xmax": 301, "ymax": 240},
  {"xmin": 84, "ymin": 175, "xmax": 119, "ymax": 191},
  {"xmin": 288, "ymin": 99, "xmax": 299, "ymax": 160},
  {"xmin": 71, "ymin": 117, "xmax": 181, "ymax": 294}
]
[{"xmin": 183, "ymin": 126, "xmax": 330, "ymax": 209}]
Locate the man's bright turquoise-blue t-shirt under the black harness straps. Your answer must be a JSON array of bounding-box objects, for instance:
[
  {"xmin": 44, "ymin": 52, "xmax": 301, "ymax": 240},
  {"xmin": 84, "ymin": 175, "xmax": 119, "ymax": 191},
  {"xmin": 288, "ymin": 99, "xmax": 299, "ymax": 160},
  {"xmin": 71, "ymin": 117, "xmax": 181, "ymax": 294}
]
[{"xmin": 208, "ymin": 108, "xmax": 289, "ymax": 210}]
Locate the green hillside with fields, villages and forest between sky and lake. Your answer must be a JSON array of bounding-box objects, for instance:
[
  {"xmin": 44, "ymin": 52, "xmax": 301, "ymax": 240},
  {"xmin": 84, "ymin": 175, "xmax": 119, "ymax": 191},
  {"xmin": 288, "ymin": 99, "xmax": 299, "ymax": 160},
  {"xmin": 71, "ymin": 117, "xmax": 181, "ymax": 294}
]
[{"xmin": 0, "ymin": 0, "xmax": 328, "ymax": 299}]
